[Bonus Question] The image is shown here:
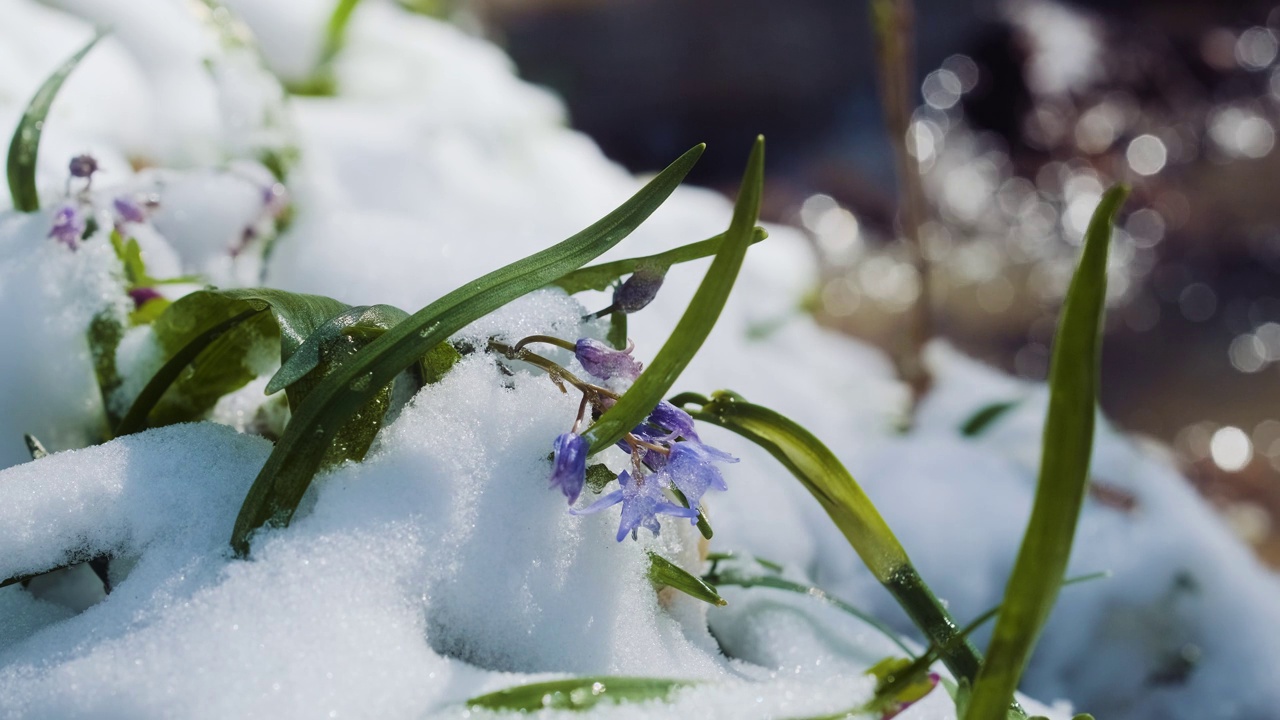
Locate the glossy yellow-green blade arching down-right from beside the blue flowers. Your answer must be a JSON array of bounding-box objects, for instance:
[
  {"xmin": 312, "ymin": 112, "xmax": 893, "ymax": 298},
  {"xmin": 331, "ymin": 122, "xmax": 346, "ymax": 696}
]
[{"xmin": 671, "ymin": 391, "xmax": 982, "ymax": 679}]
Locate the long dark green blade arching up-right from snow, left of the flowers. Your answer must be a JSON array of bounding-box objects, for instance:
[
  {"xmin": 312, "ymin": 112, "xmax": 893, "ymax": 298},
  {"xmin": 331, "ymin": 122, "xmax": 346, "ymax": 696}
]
[{"xmin": 230, "ymin": 145, "xmax": 704, "ymax": 556}]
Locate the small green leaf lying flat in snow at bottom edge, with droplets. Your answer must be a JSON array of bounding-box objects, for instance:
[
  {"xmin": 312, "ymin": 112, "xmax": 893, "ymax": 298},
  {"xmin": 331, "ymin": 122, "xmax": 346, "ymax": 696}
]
[{"xmin": 467, "ymin": 675, "xmax": 694, "ymax": 711}]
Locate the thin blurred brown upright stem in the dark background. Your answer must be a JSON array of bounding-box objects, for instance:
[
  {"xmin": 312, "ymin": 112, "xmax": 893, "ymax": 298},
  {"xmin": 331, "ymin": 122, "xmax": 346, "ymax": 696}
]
[{"xmin": 870, "ymin": 0, "xmax": 933, "ymax": 415}]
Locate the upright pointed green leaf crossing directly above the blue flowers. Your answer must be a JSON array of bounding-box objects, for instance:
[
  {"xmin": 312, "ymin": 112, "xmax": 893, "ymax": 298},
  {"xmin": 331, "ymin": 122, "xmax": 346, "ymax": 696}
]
[{"xmin": 582, "ymin": 137, "xmax": 764, "ymax": 455}]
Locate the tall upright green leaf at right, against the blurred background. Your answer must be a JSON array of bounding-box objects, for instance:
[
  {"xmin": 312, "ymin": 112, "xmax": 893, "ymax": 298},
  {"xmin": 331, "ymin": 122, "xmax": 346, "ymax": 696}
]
[{"xmin": 964, "ymin": 186, "xmax": 1128, "ymax": 720}]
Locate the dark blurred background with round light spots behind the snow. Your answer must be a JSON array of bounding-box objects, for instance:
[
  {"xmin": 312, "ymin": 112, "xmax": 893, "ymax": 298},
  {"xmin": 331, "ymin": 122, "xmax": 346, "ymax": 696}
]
[{"xmin": 453, "ymin": 0, "xmax": 1280, "ymax": 566}]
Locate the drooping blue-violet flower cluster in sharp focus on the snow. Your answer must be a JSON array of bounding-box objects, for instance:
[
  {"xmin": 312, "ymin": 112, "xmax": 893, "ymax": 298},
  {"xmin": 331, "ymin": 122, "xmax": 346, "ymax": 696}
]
[{"xmin": 541, "ymin": 338, "xmax": 737, "ymax": 542}]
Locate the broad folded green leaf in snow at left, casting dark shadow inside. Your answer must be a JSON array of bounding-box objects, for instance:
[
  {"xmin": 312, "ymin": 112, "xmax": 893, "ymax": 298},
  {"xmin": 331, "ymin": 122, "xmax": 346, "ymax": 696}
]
[{"xmin": 115, "ymin": 284, "xmax": 347, "ymax": 436}]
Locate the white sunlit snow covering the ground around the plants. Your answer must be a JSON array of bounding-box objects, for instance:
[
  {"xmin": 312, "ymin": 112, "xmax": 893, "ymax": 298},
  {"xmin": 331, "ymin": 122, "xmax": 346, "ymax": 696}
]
[{"xmin": 0, "ymin": 0, "xmax": 1280, "ymax": 720}]
